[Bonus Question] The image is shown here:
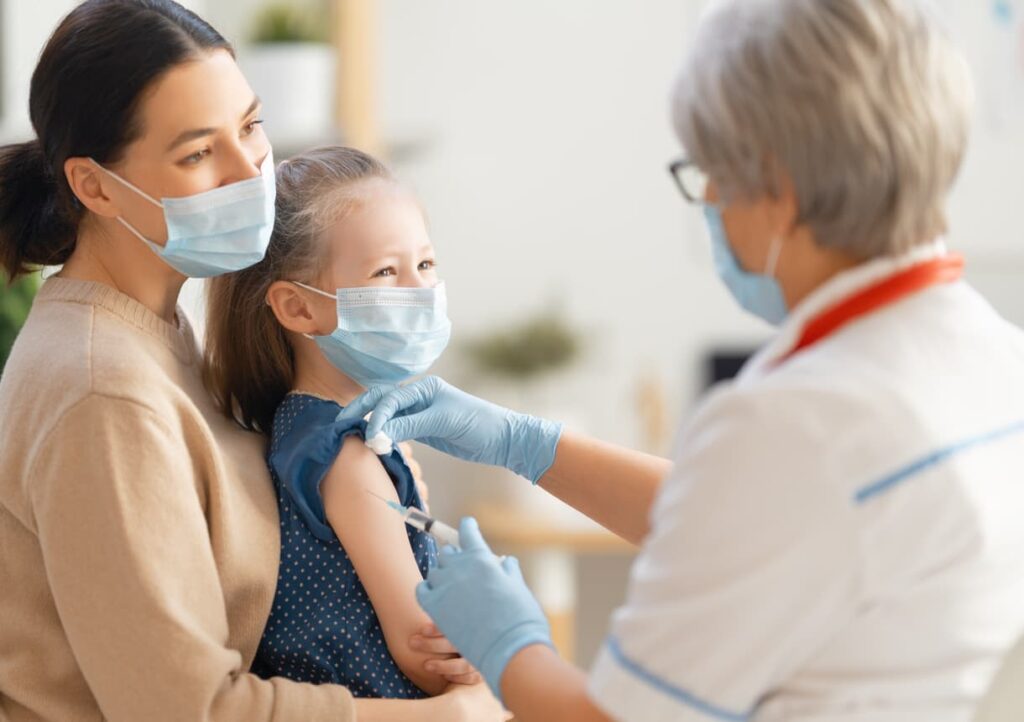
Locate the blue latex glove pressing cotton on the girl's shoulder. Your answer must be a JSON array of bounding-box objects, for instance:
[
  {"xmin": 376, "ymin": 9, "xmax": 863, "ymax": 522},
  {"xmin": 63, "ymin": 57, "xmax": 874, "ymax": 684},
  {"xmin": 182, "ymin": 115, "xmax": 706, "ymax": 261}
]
[{"xmin": 338, "ymin": 376, "xmax": 562, "ymax": 483}]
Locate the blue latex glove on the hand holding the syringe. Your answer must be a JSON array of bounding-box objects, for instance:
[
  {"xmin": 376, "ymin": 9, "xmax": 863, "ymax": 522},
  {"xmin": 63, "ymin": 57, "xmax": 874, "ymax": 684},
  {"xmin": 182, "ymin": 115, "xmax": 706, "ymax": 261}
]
[{"xmin": 416, "ymin": 516, "xmax": 554, "ymax": 699}]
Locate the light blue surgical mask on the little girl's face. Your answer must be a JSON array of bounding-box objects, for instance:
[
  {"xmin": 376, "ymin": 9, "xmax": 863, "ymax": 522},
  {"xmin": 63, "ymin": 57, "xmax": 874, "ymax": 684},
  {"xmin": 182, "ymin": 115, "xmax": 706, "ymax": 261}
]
[{"xmin": 292, "ymin": 281, "xmax": 452, "ymax": 387}]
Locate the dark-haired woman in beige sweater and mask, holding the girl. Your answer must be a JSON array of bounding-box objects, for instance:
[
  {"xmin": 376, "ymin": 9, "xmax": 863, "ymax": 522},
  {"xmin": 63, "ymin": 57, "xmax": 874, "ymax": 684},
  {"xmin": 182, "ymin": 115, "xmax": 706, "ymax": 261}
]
[{"xmin": 0, "ymin": 0, "xmax": 502, "ymax": 722}]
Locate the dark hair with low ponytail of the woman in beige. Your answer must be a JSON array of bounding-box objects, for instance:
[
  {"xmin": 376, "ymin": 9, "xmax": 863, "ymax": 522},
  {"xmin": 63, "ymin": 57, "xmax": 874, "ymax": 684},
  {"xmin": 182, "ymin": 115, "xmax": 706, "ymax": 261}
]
[{"xmin": 0, "ymin": 0, "xmax": 233, "ymax": 280}]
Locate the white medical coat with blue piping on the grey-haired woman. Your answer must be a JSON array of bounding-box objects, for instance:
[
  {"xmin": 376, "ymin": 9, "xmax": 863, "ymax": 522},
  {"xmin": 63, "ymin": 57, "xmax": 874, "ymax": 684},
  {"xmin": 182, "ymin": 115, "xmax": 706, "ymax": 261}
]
[{"xmin": 590, "ymin": 245, "xmax": 1024, "ymax": 722}]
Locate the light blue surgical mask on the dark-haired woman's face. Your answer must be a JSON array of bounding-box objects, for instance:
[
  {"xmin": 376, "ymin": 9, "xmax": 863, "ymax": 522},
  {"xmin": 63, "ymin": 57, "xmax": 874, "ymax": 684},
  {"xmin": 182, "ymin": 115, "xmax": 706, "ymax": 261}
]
[{"xmin": 92, "ymin": 153, "xmax": 276, "ymax": 279}]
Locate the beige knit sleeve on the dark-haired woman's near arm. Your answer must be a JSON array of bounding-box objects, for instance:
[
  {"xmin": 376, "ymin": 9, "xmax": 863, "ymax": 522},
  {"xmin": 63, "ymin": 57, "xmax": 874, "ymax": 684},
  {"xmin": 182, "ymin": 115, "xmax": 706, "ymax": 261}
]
[{"xmin": 29, "ymin": 395, "xmax": 355, "ymax": 722}]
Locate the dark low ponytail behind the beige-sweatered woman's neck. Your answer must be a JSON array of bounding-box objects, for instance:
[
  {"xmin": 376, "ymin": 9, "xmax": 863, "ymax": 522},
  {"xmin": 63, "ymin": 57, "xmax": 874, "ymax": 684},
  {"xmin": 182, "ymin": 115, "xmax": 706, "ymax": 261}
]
[{"xmin": 0, "ymin": 140, "xmax": 80, "ymax": 281}]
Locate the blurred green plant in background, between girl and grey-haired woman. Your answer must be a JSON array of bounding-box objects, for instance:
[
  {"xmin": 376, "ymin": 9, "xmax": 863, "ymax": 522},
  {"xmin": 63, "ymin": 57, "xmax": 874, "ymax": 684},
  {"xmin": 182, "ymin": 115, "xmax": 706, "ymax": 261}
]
[{"xmin": 463, "ymin": 311, "xmax": 583, "ymax": 381}]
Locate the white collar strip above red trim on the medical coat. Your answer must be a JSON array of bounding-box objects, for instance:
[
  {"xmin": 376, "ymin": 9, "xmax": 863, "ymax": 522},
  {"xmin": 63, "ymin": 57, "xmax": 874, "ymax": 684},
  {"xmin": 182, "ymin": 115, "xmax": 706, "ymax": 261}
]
[{"xmin": 740, "ymin": 239, "xmax": 948, "ymax": 379}]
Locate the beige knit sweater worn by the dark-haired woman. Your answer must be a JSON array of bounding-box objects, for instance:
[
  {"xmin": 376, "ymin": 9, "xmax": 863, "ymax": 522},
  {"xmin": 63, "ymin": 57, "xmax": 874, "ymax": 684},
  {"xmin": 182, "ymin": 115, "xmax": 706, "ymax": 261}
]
[{"xmin": 0, "ymin": 278, "xmax": 355, "ymax": 722}]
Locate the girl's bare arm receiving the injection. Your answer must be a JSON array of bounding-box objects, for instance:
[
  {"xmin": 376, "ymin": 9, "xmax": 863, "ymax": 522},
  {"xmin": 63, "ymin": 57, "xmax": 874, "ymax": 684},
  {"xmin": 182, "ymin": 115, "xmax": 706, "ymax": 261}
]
[{"xmin": 321, "ymin": 436, "xmax": 447, "ymax": 694}]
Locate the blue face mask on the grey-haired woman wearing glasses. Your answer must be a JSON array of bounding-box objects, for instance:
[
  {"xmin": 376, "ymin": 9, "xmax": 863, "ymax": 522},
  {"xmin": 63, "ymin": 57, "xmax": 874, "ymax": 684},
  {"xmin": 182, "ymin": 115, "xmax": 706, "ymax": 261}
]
[{"xmin": 703, "ymin": 204, "xmax": 790, "ymax": 326}]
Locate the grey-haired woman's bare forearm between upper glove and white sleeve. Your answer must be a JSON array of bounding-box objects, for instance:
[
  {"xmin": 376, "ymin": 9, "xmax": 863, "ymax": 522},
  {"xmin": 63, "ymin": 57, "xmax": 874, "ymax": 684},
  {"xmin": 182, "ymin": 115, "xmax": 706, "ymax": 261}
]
[{"xmin": 538, "ymin": 431, "xmax": 672, "ymax": 545}]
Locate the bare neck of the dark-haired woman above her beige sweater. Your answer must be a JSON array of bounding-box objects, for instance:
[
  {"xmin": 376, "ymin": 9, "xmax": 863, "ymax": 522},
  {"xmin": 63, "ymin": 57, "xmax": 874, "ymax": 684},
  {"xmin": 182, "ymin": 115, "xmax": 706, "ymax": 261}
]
[{"xmin": 57, "ymin": 218, "xmax": 185, "ymax": 324}]
